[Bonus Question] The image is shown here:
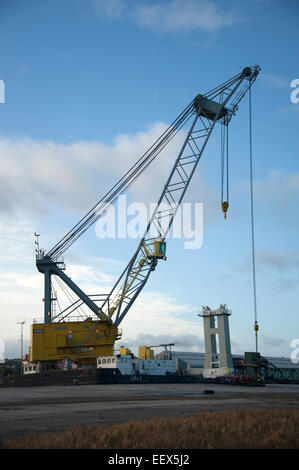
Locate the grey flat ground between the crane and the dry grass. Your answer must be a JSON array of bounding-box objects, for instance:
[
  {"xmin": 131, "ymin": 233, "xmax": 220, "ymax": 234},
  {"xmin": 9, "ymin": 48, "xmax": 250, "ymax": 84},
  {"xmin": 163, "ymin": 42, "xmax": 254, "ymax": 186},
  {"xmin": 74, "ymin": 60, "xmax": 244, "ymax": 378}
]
[{"xmin": 0, "ymin": 384, "xmax": 299, "ymax": 442}]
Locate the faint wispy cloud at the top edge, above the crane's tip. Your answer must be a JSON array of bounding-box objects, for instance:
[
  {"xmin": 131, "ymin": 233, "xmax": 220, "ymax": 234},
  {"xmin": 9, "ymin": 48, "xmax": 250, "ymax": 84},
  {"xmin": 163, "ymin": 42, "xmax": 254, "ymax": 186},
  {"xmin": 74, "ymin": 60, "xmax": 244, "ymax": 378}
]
[{"xmin": 92, "ymin": 0, "xmax": 239, "ymax": 33}]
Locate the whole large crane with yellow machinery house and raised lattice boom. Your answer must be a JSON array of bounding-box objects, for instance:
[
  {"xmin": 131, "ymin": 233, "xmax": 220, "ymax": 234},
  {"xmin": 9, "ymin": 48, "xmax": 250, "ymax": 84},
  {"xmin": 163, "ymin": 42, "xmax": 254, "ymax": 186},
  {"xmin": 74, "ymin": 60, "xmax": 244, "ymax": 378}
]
[{"xmin": 30, "ymin": 66, "xmax": 260, "ymax": 374}]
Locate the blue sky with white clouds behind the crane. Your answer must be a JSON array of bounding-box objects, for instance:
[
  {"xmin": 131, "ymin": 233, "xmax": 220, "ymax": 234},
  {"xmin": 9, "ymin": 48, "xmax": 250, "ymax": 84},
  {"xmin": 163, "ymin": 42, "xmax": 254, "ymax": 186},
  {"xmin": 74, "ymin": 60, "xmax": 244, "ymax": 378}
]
[{"xmin": 0, "ymin": 0, "xmax": 299, "ymax": 357}]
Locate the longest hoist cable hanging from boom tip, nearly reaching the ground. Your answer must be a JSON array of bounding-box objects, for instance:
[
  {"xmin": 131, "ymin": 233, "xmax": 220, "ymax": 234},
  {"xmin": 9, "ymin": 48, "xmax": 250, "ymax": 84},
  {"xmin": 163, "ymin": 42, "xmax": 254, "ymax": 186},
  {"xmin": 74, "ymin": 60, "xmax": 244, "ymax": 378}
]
[{"xmin": 249, "ymin": 87, "xmax": 258, "ymax": 352}]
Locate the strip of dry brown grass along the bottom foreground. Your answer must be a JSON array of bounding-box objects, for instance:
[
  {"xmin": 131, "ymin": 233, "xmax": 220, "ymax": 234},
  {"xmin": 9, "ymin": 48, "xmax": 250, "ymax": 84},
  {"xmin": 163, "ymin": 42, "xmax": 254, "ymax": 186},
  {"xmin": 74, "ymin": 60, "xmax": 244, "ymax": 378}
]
[{"xmin": 2, "ymin": 409, "xmax": 299, "ymax": 449}]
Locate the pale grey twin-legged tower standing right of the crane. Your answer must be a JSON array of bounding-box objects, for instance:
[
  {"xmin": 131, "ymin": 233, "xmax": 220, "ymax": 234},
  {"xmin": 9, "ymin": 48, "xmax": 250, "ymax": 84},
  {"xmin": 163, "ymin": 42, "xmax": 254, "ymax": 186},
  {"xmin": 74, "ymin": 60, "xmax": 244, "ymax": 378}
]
[{"xmin": 199, "ymin": 305, "xmax": 233, "ymax": 369}]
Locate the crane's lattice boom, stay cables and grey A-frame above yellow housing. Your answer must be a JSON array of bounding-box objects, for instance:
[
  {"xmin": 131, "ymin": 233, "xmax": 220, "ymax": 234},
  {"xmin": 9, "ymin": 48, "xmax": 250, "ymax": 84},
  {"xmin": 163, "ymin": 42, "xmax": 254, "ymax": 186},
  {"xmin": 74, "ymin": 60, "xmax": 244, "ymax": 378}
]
[{"xmin": 33, "ymin": 65, "xmax": 260, "ymax": 366}]
